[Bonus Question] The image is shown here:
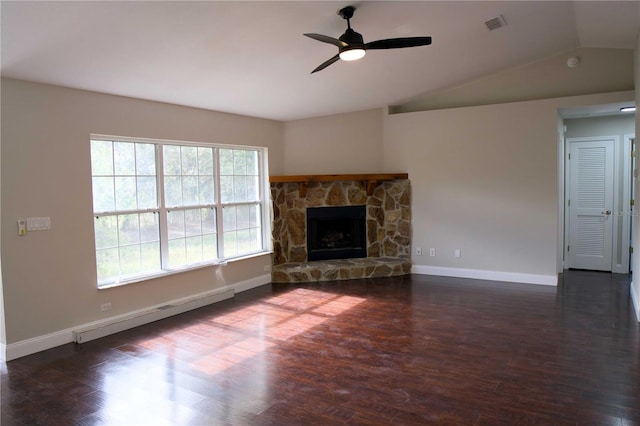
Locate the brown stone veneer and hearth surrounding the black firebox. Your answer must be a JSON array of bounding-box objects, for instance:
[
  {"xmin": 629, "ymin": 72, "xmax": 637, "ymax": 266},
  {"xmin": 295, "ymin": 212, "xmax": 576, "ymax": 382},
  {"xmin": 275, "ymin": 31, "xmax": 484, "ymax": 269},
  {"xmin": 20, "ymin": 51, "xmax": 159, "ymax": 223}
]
[{"xmin": 271, "ymin": 179, "xmax": 411, "ymax": 282}]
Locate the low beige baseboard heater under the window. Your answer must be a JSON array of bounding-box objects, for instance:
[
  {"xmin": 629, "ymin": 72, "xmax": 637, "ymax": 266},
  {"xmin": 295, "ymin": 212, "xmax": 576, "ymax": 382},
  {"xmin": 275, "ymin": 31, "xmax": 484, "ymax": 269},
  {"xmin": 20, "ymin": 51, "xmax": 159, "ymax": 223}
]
[{"xmin": 73, "ymin": 288, "xmax": 234, "ymax": 343}]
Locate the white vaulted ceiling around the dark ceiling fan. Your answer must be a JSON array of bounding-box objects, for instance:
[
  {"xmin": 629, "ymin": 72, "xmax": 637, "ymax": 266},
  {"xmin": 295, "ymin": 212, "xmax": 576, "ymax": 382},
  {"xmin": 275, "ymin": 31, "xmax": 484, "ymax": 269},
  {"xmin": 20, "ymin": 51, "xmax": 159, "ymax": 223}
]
[{"xmin": 1, "ymin": 1, "xmax": 640, "ymax": 121}]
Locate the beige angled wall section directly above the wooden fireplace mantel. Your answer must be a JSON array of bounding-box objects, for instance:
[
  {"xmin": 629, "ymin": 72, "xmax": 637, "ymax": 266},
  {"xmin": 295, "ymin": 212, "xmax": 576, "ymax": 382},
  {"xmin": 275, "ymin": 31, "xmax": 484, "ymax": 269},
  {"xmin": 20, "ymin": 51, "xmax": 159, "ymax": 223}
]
[{"xmin": 282, "ymin": 109, "xmax": 383, "ymax": 175}]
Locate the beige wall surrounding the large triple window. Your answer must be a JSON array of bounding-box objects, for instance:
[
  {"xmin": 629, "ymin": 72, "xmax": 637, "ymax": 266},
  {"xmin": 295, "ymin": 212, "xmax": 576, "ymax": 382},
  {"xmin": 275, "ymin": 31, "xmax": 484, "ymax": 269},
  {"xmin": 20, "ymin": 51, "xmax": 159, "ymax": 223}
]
[{"xmin": 1, "ymin": 79, "xmax": 283, "ymax": 344}]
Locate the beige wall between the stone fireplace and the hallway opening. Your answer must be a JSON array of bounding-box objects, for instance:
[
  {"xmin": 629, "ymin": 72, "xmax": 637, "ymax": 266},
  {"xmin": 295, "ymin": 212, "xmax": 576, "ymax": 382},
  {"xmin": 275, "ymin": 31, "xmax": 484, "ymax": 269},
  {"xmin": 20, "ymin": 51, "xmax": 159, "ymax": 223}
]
[{"xmin": 384, "ymin": 92, "xmax": 633, "ymax": 277}]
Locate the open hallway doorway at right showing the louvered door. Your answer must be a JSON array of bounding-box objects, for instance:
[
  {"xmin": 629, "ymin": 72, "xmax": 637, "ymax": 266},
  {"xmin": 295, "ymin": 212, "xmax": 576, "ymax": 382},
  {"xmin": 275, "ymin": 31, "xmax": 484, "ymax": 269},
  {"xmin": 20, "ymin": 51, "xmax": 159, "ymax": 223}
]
[{"xmin": 559, "ymin": 110, "xmax": 635, "ymax": 274}]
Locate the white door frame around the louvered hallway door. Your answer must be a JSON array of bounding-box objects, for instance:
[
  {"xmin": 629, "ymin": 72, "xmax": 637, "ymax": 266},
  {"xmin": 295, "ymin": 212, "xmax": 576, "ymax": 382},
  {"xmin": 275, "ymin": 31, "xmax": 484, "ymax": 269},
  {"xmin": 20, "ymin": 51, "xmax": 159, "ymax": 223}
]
[{"xmin": 562, "ymin": 135, "xmax": 631, "ymax": 274}]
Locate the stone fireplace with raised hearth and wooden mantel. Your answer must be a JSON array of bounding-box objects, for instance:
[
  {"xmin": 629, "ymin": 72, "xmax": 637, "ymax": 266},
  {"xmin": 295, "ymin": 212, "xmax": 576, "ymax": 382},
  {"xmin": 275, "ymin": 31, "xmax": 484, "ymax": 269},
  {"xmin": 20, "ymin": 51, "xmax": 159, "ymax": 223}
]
[{"xmin": 270, "ymin": 174, "xmax": 411, "ymax": 282}]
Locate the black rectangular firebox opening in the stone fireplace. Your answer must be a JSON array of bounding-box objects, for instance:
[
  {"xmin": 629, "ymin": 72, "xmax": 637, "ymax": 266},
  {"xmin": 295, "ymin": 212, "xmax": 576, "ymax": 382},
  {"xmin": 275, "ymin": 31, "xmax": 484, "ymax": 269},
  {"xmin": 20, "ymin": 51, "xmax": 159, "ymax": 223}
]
[{"xmin": 307, "ymin": 206, "xmax": 367, "ymax": 260}]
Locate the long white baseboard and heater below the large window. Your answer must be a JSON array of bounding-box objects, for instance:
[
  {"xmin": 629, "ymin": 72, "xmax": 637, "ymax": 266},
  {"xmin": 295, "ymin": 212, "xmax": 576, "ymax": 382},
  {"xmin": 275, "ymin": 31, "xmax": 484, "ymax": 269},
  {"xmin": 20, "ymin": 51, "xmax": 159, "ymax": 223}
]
[{"xmin": 0, "ymin": 274, "xmax": 271, "ymax": 361}]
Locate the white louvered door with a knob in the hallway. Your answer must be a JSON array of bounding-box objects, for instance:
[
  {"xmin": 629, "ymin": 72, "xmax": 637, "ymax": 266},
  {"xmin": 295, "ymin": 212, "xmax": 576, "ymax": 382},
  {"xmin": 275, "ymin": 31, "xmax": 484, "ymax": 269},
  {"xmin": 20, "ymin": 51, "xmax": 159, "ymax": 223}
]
[{"xmin": 568, "ymin": 138, "xmax": 615, "ymax": 271}]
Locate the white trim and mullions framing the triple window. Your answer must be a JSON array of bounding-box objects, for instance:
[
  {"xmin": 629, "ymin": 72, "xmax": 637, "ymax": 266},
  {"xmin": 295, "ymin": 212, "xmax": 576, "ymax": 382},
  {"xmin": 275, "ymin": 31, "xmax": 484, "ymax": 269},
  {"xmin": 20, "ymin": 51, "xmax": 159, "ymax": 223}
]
[{"xmin": 89, "ymin": 133, "xmax": 272, "ymax": 290}]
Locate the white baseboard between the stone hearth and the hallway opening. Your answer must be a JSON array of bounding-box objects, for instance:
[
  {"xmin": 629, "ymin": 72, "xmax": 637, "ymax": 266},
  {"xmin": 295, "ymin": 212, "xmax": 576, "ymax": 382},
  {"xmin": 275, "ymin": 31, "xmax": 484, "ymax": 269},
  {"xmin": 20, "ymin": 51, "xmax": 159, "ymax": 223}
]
[{"xmin": 411, "ymin": 265, "xmax": 558, "ymax": 286}]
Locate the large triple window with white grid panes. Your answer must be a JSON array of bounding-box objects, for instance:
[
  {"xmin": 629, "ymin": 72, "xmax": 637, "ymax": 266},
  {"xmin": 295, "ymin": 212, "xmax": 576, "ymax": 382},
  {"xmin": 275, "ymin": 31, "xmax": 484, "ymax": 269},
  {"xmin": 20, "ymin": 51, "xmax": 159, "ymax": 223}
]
[{"xmin": 91, "ymin": 137, "xmax": 268, "ymax": 287}]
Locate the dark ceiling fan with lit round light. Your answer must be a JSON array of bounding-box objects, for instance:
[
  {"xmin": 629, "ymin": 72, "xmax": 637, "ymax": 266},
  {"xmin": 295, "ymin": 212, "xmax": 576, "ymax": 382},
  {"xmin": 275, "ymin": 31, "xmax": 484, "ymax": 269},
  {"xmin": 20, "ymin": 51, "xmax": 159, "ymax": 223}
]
[{"xmin": 304, "ymin": 6, "xmax": 431, "ymax": 74}]
